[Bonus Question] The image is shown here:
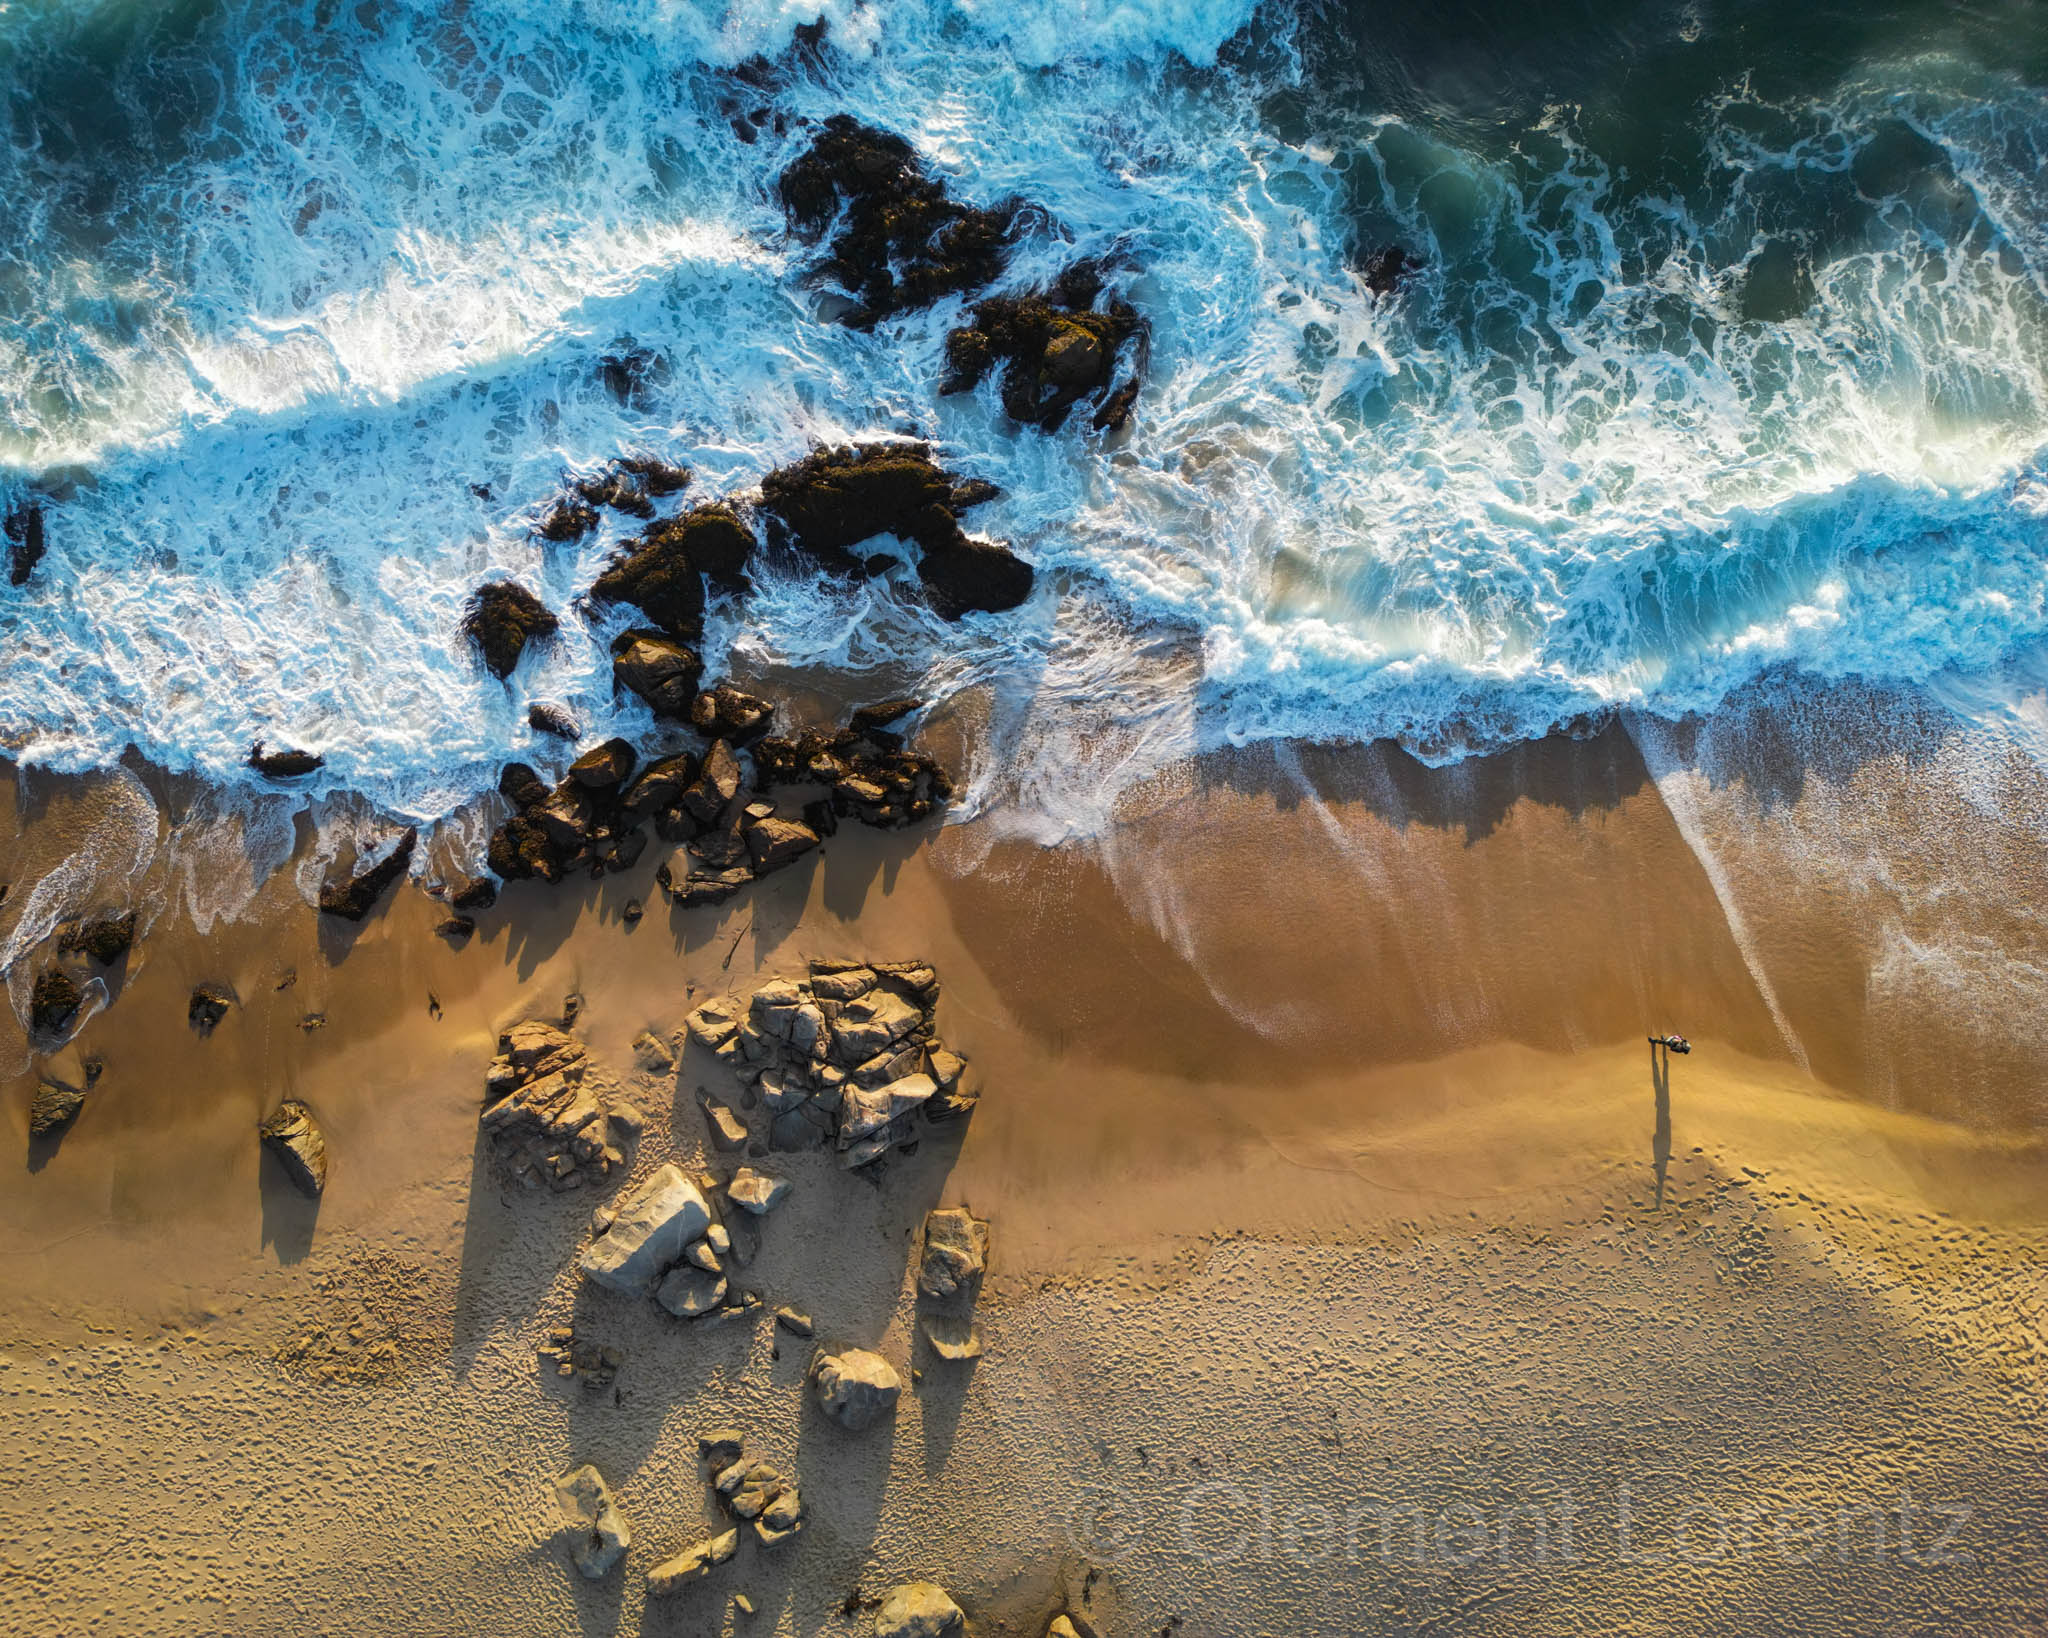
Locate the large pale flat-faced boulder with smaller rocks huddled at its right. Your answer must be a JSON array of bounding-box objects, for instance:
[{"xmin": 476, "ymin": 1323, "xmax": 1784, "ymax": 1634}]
[{"xmin": 578, "ymin": 1165, "xmax": 788, "ymax": 1325}]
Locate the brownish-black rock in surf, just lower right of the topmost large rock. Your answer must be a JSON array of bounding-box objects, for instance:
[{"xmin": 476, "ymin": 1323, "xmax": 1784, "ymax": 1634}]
[{"xmin": 940, "ymin": 262, "xmax": 1143, "ymax": 432}]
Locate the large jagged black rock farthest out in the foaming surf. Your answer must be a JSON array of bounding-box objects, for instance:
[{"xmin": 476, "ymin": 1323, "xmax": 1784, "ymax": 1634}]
[{"xmin": 776, "ymin": 115, "xmax": 1020, "ymax": 330}]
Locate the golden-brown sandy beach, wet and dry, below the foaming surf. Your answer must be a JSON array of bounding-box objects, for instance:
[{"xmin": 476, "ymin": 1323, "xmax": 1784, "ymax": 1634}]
[{"xmin": 0, "ymin": 731, "xmax": 2048, "ymax": 1638}]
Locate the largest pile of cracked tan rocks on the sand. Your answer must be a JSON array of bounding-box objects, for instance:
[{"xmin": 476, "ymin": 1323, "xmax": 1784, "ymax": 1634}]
[{"xmin": 686, "ymin": 960, "xmax": 977, "ymax": 1169}]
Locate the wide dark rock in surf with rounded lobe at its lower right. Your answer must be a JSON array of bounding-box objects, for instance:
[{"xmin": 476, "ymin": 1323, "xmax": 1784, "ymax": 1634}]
[{"xmin": 762, "ymin": 442, "xmax": 1032, "ymax": 620}]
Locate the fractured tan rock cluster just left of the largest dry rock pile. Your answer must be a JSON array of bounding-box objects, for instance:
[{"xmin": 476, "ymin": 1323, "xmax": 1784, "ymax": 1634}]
[{"xmin": 483, "ymin": 1020, "xmax": 641, "ymax": 1194}]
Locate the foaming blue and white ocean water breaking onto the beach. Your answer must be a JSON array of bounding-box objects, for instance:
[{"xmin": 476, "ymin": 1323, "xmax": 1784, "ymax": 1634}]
[{"xmin": 0, "ymin": 0, "xmax": 2048, "ymax": 837}]
